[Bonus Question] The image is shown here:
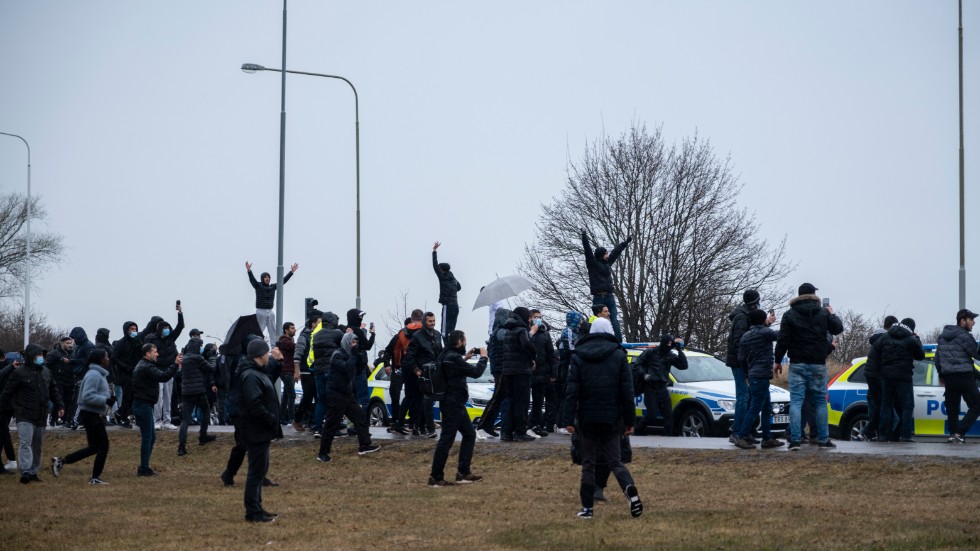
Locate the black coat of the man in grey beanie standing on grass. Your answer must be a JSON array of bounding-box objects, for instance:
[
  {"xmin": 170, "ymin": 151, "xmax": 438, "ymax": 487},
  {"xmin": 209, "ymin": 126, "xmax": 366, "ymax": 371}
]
[{"xmin": 235, "ymin": 358, "xmax": 282, "ymax": 444}]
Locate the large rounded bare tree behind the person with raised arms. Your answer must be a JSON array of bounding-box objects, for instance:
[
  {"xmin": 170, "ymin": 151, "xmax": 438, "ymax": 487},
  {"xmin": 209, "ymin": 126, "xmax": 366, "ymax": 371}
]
[{"xmin": 520, "ymin": 126, "xmax": 794, "ymax": 352}]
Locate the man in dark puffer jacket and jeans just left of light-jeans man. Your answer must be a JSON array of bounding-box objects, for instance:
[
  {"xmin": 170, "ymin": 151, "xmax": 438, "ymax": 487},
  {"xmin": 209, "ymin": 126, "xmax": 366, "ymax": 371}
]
[{"xmin": 735, "ymin": 308, "xmax": 783, "ymax": 450}]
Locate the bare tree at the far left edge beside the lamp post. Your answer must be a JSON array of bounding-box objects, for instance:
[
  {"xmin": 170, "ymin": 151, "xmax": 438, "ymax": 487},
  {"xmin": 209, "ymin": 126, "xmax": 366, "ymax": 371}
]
[{"xmin": 0, "ymin": 193, "xmax": 63, "ymax": 298}]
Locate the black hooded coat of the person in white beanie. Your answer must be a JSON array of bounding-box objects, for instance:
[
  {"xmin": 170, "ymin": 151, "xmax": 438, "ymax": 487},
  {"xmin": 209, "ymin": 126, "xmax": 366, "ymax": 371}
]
[{"xmin": 562, "ymin": 333, "xmax": 636, "ymax": 427}]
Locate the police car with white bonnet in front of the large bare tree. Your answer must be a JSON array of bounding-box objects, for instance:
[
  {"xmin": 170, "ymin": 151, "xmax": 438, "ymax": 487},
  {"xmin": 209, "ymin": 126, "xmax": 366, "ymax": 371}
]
[{"xmin": 624, "ymin": 344, "xmax": 789, "ymax": 437}]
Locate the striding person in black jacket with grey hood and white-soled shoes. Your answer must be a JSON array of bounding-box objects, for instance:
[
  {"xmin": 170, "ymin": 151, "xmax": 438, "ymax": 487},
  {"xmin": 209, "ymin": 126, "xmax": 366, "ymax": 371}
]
[{"xmin": 317, "ymin": 333, "xmax": 380, "ymax": 463}]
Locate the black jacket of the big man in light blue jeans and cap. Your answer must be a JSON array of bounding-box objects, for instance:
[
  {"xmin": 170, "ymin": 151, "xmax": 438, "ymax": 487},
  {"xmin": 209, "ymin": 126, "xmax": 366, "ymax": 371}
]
[{"xmin": 776, "ymin": 295, "xmax": 844, "ymax": 365}]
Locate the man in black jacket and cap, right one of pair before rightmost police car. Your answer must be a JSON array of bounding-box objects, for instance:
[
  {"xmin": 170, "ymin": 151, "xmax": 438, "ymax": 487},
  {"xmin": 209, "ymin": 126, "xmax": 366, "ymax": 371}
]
[{"xmin": 868, "ymin": 318, "xmax": 925, "ymax": 442}]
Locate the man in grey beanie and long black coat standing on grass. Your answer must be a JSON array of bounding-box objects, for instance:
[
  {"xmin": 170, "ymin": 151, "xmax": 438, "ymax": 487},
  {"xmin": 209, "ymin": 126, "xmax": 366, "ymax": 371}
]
[{"xmin": 235, "ymin": 339, "xmax": 282, "ymax": 522}]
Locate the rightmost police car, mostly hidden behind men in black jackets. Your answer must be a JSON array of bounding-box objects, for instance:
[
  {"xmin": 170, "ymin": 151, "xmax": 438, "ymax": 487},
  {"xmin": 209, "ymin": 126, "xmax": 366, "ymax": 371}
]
[{"xmin": 827, "ymin": 344, "xmax": 980, "ymax": 440}]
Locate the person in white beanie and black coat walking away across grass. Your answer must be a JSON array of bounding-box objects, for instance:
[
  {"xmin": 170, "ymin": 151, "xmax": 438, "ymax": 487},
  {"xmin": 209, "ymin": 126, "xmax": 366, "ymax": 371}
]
[{"xmin": 562, "ymin": 318, "xmax": 643, "ymax": 519}]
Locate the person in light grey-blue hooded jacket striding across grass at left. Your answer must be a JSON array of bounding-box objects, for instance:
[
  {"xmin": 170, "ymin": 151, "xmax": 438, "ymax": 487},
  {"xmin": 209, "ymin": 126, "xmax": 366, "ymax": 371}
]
[{"xmin": 51, "ymin": 348, "xmax": 116, "ymax": 485}]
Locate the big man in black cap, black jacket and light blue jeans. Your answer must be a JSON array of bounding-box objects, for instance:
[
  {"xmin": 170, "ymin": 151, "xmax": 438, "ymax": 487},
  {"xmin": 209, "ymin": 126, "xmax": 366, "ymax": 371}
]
[{"xmin": 772, "ymin": 283, "xmax": 844, "ymax": 451}]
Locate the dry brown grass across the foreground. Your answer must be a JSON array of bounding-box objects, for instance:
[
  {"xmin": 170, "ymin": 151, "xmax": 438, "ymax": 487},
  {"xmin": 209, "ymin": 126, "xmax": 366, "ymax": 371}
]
[{"xmin": 7, "ymin": 431, "xmax": 980, "ymax": 550}]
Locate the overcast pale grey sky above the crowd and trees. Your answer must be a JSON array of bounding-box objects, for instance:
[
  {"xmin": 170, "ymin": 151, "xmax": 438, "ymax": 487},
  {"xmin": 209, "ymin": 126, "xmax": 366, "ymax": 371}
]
[{"xmin": 0, "ymin": 0, "xmax": 980, "ymax": 350}]
